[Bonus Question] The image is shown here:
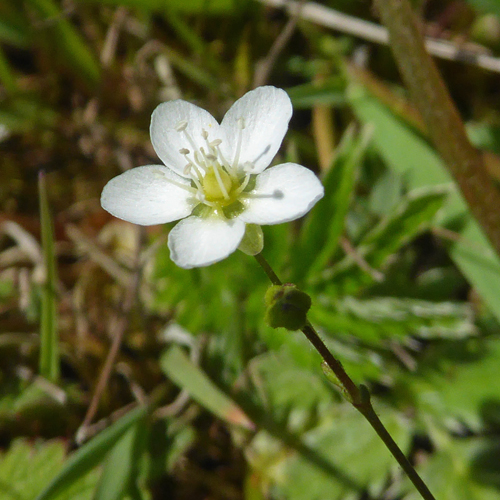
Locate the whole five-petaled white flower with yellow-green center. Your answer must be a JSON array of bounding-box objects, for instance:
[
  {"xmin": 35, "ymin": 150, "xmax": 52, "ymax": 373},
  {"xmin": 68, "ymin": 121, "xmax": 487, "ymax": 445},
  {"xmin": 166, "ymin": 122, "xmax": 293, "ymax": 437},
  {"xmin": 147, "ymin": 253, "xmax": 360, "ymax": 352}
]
[{"xmin": 101, "ymin": 86, "xmax": 323, "ymax": 269}]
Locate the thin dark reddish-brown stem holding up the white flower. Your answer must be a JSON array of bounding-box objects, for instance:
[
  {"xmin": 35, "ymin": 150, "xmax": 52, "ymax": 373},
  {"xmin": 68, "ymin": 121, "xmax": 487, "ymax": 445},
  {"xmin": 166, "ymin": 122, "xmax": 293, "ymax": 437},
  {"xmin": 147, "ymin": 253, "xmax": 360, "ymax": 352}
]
[{"xmin": 255, "ymin": 253, "xmax": 435, "ymax": 500}]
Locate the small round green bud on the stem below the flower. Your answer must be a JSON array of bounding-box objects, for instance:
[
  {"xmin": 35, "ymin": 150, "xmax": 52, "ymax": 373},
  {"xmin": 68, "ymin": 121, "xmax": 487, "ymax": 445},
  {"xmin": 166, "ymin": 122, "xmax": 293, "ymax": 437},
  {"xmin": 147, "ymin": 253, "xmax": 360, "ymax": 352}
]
[{"xmin": 266, "ymin": 283, "xmax": 311, "ymax": 331}]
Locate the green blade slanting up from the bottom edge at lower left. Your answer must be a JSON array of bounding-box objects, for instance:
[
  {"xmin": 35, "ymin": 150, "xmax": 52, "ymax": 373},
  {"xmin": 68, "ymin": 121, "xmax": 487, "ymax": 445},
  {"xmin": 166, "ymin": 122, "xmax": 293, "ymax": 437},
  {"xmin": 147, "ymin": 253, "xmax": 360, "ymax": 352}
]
[{"xmin": 36, "ymin": 406, "xmax": 148, "ymax": 500}]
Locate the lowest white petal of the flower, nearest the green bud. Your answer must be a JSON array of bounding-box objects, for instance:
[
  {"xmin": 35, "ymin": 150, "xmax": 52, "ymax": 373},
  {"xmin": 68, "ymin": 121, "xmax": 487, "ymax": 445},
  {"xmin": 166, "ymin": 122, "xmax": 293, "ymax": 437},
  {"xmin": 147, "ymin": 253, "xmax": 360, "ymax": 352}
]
[{"xmin": 168, "ymin": 216, "xmax": 245, "ymax": 269}]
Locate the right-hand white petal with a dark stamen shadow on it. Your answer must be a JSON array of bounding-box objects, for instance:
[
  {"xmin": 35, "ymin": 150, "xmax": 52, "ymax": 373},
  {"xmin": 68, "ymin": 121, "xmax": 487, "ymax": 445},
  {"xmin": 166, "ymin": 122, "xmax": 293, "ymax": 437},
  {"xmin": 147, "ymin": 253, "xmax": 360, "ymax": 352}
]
[{"xmin": 239, "ymin": 163, "xmax": 324, "ymax": 224}]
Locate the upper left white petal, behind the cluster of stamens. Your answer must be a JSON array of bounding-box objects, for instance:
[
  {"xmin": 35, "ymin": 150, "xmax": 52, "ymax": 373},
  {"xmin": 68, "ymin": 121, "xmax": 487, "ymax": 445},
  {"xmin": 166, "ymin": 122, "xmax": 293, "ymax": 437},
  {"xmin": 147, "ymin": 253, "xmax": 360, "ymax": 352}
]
[{"xmin": 150, "ymin": 99, "xmax": 224, "ymax": 176}]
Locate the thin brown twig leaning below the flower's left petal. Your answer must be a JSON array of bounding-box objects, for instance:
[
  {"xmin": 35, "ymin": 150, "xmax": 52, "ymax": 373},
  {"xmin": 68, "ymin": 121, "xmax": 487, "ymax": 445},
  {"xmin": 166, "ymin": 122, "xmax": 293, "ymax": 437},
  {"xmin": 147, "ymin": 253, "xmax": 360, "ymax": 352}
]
[{"xmin": 76, "ymin": 228, "xmax": 144, "ymax": 442}]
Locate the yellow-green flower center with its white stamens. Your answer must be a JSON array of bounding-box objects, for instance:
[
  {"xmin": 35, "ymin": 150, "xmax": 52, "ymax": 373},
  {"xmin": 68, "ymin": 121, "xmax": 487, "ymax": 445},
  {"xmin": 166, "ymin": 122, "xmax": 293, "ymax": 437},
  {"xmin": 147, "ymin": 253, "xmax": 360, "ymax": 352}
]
[{"xmin": 175, "ymin": 119, "xmax": 252, "ymax": 216}]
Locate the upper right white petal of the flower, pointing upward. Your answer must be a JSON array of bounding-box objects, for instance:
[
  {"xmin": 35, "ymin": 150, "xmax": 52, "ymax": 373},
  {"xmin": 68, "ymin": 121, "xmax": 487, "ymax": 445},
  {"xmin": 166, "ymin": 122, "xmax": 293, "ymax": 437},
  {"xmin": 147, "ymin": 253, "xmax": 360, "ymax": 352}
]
[{"xmin": 221, "ymin": 86, "xmax": 292, "ymax": 174}]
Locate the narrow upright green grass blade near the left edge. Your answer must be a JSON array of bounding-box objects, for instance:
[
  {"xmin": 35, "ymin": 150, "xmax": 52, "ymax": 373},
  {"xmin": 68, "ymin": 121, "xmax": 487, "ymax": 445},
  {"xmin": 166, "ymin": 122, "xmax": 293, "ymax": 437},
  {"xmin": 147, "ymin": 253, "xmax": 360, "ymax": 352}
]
[{"xmin": 38, "ymin": 172, "xmax": 59, "ymax": 382}]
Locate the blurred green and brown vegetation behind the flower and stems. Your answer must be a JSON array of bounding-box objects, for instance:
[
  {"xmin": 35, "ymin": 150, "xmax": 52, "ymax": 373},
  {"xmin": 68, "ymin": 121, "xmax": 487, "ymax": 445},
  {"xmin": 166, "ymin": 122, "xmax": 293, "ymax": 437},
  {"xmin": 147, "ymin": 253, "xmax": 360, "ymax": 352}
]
[{"xmin": 0, "ymin": 0, "xmax": 500, "ymax": 500}]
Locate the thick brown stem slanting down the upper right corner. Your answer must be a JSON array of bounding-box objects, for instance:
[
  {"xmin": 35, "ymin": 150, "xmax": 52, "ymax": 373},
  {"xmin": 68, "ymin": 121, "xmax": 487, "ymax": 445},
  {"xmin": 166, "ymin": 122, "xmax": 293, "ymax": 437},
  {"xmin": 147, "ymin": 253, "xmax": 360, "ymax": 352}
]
[{"xmin": 374, "ymin": 0, "xmax": 500, "ymax": 264}]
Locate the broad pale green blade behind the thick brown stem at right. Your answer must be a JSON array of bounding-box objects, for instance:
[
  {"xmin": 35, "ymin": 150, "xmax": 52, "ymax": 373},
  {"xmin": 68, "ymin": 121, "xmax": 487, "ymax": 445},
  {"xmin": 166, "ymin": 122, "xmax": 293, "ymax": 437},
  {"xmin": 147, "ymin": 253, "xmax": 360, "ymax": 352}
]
[{"xmin": 348, "ymin": 85, "xmax": 500, "ymax": 319}]
